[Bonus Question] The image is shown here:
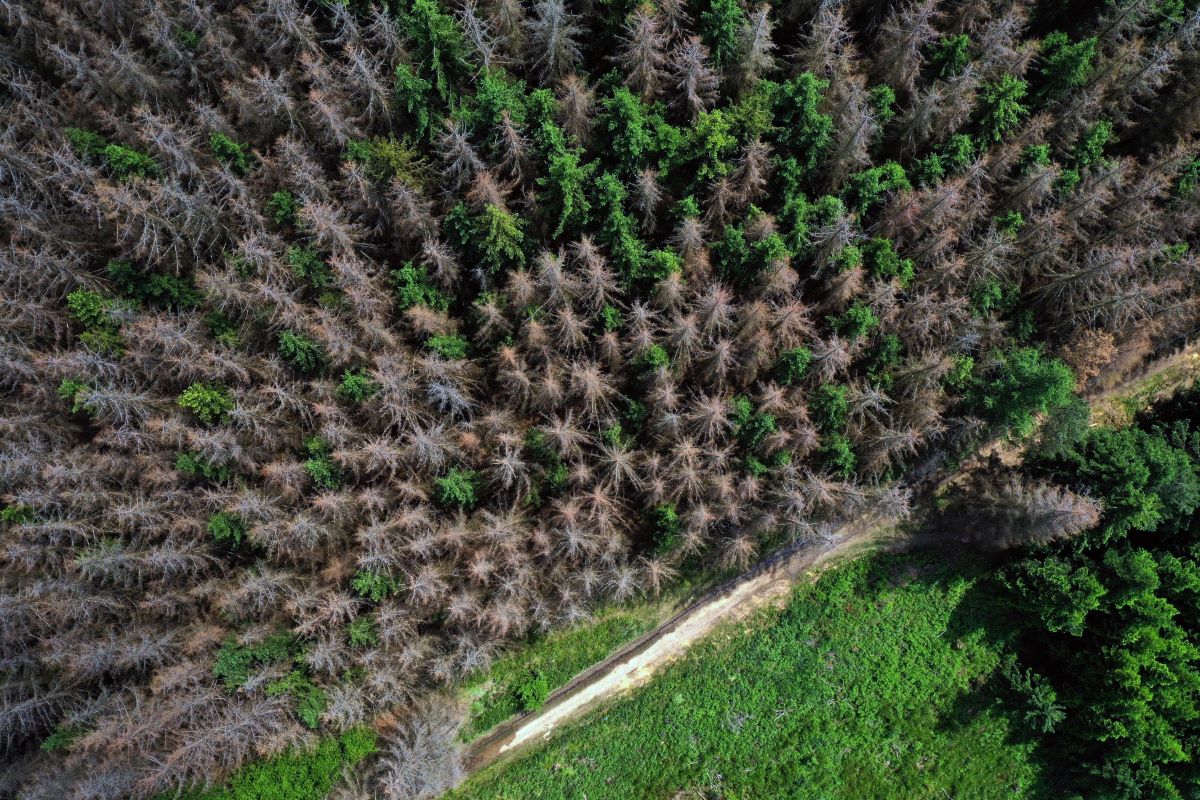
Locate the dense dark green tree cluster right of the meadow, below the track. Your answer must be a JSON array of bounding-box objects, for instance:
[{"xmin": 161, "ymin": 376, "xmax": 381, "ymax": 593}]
[{"xmin": 984, "ymin": 385, "xmax": 1200, "ymax": 800}]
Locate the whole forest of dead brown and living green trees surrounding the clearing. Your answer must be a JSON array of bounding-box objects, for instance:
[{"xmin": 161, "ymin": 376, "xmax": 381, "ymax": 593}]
[{"xmin": 0, "ymin": 0, "xmax": 1200, "ymax": 800}]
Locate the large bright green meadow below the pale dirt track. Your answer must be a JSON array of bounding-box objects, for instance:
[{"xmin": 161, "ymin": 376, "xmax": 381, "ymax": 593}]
[{"xmin": 448, "ymin": 557, "xmax": 1039, "ymax": 800}]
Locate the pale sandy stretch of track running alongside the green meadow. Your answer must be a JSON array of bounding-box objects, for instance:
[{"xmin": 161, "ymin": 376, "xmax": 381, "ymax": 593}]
[{"xmin": 453, "ymin": 524, "xmax": 871, "ymax": 775}]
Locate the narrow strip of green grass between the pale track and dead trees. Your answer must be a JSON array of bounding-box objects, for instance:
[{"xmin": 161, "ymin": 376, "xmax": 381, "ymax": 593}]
[{"xmin": 462, "ymin": 604, "xmax": 659, "ymax": 741}]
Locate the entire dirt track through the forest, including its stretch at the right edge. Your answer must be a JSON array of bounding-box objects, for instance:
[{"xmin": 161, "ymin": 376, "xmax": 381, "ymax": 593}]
[{"xmin": 451, "ymin": 341, "xmax": 1200, "ymax": 780}]
